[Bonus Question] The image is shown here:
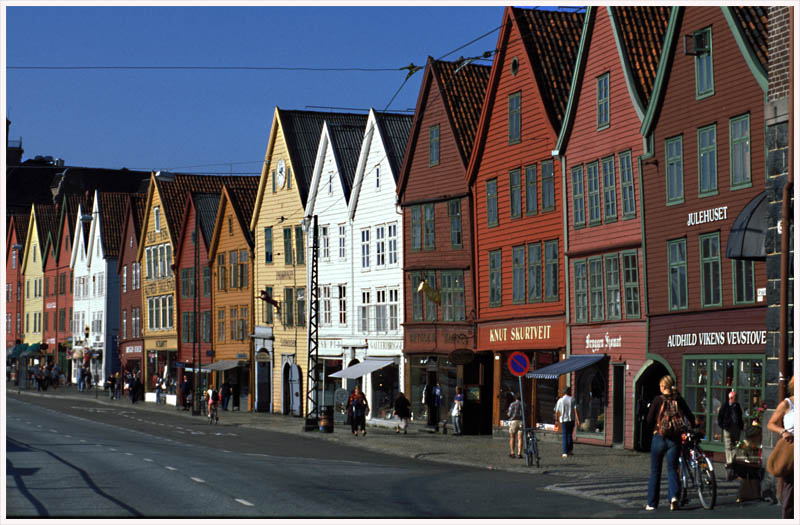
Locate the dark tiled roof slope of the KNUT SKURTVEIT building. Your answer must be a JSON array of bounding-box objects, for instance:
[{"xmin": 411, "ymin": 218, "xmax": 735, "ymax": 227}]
[{"xmin": 511, "ymin": 7, "xmax": 585, "ymax": 130}]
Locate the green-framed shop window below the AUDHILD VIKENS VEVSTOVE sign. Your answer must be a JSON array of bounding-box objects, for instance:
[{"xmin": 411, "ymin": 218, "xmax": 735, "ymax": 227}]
[{"xmin": 683, "ymin": 356, "xmax": 766, "ymax": 446}]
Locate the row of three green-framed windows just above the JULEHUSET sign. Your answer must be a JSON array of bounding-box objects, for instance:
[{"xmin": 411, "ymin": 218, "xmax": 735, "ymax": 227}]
[{"xmin": 664, "ymin": 115, "xmax": 752, "ymax": 205}]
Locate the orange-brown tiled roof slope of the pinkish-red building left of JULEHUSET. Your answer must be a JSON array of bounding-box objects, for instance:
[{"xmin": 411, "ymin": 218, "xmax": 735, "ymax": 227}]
[{"xmin": 611, "ymin": 6, "xmax": 671, "ymax": 107}]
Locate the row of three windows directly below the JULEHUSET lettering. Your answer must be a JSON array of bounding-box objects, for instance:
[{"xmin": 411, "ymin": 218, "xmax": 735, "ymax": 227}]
[{"xmin": 667, "ymin": 232, "xmax": 755, "ymax": 310}]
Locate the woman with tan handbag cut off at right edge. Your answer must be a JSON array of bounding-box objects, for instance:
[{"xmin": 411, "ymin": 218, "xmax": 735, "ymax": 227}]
[{"xmin": 767, "ymin": 376, "xmax": 794, "ymax": 519}]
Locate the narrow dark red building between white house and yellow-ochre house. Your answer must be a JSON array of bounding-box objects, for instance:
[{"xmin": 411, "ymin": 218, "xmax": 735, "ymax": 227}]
[{"xmin": 117, "ymin": 194, "xmax": 145, "ymax": 374}]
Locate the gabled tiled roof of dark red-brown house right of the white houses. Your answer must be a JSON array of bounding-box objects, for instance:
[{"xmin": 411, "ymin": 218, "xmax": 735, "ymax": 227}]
[{"xmin": 397, "ymin": 56, "xmax": 491, "ymax": 195}]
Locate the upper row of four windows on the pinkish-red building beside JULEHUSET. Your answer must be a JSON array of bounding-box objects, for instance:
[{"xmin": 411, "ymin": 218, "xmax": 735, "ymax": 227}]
[{"xmin": 571, "ymin": 151, "xmax": 636, "ymax": 228}]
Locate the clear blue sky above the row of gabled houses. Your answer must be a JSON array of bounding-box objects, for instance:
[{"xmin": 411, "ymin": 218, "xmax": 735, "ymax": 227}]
[{"xmin": 6, "ymin": 6, "xmax": 503, "ymax": 173}]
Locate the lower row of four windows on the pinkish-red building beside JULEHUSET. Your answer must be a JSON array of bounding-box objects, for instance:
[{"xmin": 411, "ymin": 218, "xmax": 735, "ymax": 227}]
[{"xmin": 574, "ymin": 251, "xmax": 640, "ymax": 323}]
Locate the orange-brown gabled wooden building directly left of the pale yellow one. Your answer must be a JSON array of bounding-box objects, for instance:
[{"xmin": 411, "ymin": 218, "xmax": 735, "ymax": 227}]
[{"xmin": 208, "ymin": 177, "xmax": 259, "ymax": 410}]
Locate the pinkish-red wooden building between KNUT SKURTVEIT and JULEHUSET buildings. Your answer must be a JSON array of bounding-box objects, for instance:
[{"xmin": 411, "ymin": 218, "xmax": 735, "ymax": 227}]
[{"xmin": 555, "ymin": 7, "xmax": 670, "ymax": 448}]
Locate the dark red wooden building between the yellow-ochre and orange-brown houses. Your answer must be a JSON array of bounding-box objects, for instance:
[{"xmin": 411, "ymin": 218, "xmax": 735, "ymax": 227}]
[{"xmin": 175, "ymin": 192, "xmax": 220, "ymax": 406}]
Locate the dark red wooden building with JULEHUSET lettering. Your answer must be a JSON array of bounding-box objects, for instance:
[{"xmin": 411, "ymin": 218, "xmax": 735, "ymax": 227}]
[{"xmin": 642, "ymin": 7, "xmax": 767, "ymax": 450}]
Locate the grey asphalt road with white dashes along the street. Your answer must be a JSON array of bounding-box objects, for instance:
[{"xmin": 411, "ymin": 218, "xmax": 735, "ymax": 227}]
[{"xmin": 6, "ymin": 397, "xmax": 774, "ymax": 519}]
